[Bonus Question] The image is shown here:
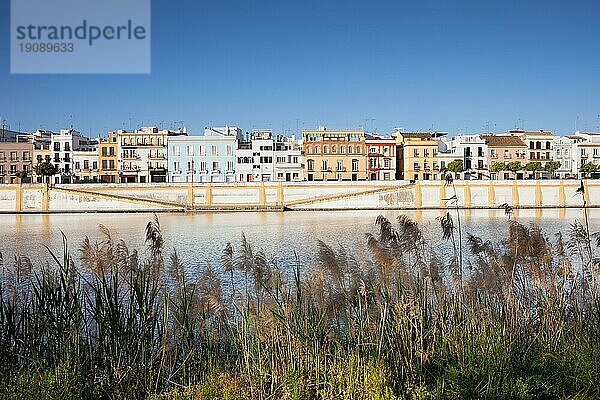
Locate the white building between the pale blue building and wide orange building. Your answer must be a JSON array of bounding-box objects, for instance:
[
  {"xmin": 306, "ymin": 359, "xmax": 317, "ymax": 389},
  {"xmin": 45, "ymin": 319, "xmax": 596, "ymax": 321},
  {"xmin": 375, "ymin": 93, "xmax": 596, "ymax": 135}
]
[{"xmin": 236, "ymin": 130, "xmax": 304, "ymax": 182}]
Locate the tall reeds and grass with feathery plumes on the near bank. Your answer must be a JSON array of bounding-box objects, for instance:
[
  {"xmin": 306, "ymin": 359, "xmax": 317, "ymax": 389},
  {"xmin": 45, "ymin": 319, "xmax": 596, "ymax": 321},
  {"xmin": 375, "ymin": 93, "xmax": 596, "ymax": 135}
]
[{"xmin": 0, "ymin": 215, "xmax": 600, "ymax": 399}]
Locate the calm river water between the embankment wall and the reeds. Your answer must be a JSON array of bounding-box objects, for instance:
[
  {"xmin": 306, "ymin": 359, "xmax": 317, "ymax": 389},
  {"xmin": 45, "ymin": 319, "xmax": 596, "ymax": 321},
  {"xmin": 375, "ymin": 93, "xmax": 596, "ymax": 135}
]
[{"xmin": 0, "ymin": 209, "xmax": 600, "ymax": 276}]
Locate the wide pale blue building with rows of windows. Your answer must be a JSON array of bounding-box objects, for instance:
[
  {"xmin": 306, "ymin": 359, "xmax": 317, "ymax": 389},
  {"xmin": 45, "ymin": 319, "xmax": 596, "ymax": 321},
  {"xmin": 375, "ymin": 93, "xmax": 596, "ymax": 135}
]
[{"xmin": 168, "ymin": 126, "xmax": 242, "ymax": 183}]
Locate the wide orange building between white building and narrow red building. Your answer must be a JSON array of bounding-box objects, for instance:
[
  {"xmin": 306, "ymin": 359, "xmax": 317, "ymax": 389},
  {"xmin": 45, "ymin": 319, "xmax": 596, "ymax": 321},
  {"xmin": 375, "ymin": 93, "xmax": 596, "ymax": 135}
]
[{"xmin": 302, "ymin": 127, "xmax": 367, "ymax": 181}]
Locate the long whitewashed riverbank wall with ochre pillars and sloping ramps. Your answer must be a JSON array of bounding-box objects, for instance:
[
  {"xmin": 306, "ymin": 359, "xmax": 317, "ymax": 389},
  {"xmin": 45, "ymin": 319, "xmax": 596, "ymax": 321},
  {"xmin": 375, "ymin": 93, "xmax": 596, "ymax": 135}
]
[{"xmin": 0, "ymin": 180, "xmax": 600, "ymax": 213}]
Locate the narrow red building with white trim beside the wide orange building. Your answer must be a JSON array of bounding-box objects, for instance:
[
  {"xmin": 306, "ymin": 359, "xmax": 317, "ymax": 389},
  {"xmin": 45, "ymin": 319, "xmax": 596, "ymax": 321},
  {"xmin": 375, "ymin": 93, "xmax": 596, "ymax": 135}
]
[{"xmin": 365, "ymin": 134, "xmax": 396, "ymax": 181}]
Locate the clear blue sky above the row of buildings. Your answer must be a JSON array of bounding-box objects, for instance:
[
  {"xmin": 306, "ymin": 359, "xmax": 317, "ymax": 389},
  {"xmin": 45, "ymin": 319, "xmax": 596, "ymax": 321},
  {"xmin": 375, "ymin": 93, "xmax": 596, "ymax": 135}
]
[{"xmin": 0, "ymin": 0, "xmax": 600, "ymax": 136}]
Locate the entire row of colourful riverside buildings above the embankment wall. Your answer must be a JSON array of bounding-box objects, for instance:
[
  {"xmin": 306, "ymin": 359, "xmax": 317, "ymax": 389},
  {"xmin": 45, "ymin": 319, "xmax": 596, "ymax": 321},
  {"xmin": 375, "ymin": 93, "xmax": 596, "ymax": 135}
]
[{"xmin": 0, "ymin": 126, "xmax": 600, "ymax": 184}]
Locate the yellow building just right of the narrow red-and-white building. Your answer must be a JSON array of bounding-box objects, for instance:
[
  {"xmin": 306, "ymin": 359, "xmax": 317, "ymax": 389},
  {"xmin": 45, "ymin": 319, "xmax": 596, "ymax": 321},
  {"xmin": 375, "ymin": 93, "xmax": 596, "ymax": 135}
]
[{"xmin": 396, "ymin": 132, "xmax": 439, "ymax": 181}]
